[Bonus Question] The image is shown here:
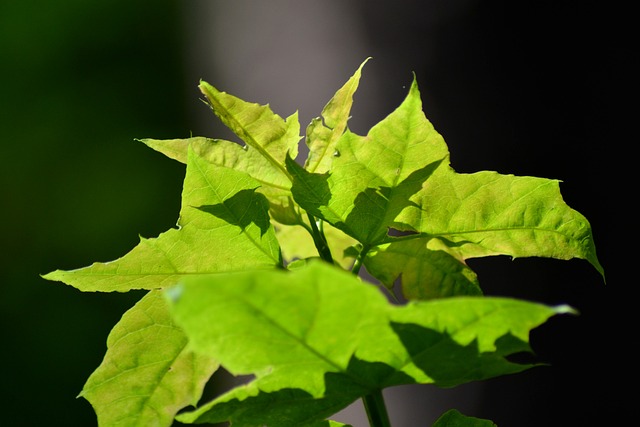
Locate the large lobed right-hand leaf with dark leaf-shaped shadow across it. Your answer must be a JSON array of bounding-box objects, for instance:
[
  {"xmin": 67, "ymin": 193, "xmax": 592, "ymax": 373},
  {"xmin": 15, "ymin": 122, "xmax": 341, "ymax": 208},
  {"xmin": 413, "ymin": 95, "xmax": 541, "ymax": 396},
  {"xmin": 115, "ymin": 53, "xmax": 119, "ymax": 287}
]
[{"xmin": 286, "ymin": 71, "xmax": 604, "ymax": 299}]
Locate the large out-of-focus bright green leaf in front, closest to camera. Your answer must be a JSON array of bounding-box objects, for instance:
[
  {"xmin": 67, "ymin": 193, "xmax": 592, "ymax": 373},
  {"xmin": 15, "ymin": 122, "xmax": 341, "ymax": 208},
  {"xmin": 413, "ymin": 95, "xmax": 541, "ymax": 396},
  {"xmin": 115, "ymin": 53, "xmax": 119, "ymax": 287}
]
[{"xmin": 167, "ymin": 262, "xmax": 571, "ymax": 427}]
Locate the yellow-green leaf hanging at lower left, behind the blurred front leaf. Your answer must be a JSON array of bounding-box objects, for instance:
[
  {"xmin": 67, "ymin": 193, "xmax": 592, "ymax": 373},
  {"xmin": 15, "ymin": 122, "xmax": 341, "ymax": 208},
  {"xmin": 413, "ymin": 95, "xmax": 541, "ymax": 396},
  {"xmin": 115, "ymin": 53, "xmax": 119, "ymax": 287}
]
[{"xmin": 80, "ymin": 291, "xmax": 219, "ymax": 427}]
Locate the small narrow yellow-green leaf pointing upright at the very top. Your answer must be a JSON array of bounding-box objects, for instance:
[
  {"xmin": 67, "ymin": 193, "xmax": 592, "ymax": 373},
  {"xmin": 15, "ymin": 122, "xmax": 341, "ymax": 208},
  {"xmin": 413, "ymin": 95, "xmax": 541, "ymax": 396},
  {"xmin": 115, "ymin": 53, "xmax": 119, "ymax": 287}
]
[{"xmin": 305, "ymin": 58, "xmax": 370, "ymax": 173}]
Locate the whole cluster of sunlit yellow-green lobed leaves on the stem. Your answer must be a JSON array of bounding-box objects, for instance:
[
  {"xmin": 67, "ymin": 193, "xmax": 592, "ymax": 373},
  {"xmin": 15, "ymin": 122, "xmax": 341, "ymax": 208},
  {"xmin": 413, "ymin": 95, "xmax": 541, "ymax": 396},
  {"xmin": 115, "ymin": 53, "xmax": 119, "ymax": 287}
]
[{"xmin": 44, "ymin": 61, "xmax": 604, "ymax": 427}]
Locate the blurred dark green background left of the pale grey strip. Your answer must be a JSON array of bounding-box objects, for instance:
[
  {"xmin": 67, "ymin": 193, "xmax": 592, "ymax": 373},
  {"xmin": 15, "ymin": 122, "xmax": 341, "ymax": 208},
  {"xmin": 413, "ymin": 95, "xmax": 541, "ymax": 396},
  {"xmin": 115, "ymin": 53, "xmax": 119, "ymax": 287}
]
[{"xmin": 0, "ymin": 0, "xmax": 189, "ymax": 427}]
